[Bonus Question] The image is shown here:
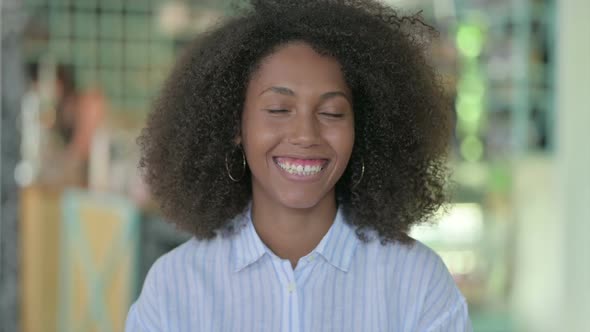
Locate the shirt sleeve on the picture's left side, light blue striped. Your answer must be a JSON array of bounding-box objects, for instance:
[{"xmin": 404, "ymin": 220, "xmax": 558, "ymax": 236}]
[{"xmin": 125, "ymin": 262, "xmax": 162, "ymax": 332}]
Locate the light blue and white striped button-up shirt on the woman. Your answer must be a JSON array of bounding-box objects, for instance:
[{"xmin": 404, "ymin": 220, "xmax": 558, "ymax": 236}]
[{"xmin": 125, "ymin": 205, "xmax": 471, "ymax": 332}]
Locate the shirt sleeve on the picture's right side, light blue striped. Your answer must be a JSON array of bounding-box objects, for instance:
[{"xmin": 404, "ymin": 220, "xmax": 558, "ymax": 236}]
[{"xmin": 418, "ymin": 255, "xmax": 473, "ymax": 332}]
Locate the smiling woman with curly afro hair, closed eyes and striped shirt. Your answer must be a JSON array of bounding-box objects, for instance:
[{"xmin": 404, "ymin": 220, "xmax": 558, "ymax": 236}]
[{"xmin": 126, "ymin": 0, "xmax": 470, "ymax": 332}]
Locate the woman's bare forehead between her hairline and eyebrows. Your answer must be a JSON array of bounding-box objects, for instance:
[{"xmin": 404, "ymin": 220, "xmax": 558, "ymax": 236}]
[{"xmin": 250, "ymin": 42, "xmax": 348, "ymax": 91}]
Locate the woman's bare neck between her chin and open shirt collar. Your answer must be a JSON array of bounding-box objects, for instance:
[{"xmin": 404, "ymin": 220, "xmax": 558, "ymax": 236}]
[{"xmin": 252, "ymin": 195, "xmax": 337, "ymax": 268}]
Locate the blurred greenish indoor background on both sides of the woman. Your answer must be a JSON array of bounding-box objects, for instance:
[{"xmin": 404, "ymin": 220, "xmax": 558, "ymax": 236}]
[{"xmin": 0, "ymin": 0, "xmax": 590, "ymax": 332}]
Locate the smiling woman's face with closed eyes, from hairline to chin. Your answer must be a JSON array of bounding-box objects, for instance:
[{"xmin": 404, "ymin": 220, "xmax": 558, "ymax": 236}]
[{"xmin": 238, "ymin": 42, "xmax": 354, "ymax": 209}]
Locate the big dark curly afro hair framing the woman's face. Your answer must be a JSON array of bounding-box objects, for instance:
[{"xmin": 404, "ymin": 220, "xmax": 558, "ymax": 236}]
[{"xmin": 138, "ymin": 0, "xmax": 453, "ymax": 243}]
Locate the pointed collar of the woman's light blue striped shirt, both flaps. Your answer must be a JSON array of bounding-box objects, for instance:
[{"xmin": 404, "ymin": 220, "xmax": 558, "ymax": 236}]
[{"xmin": 231, "ymin": 204, "xmax": 360, "ymax": 272}]
